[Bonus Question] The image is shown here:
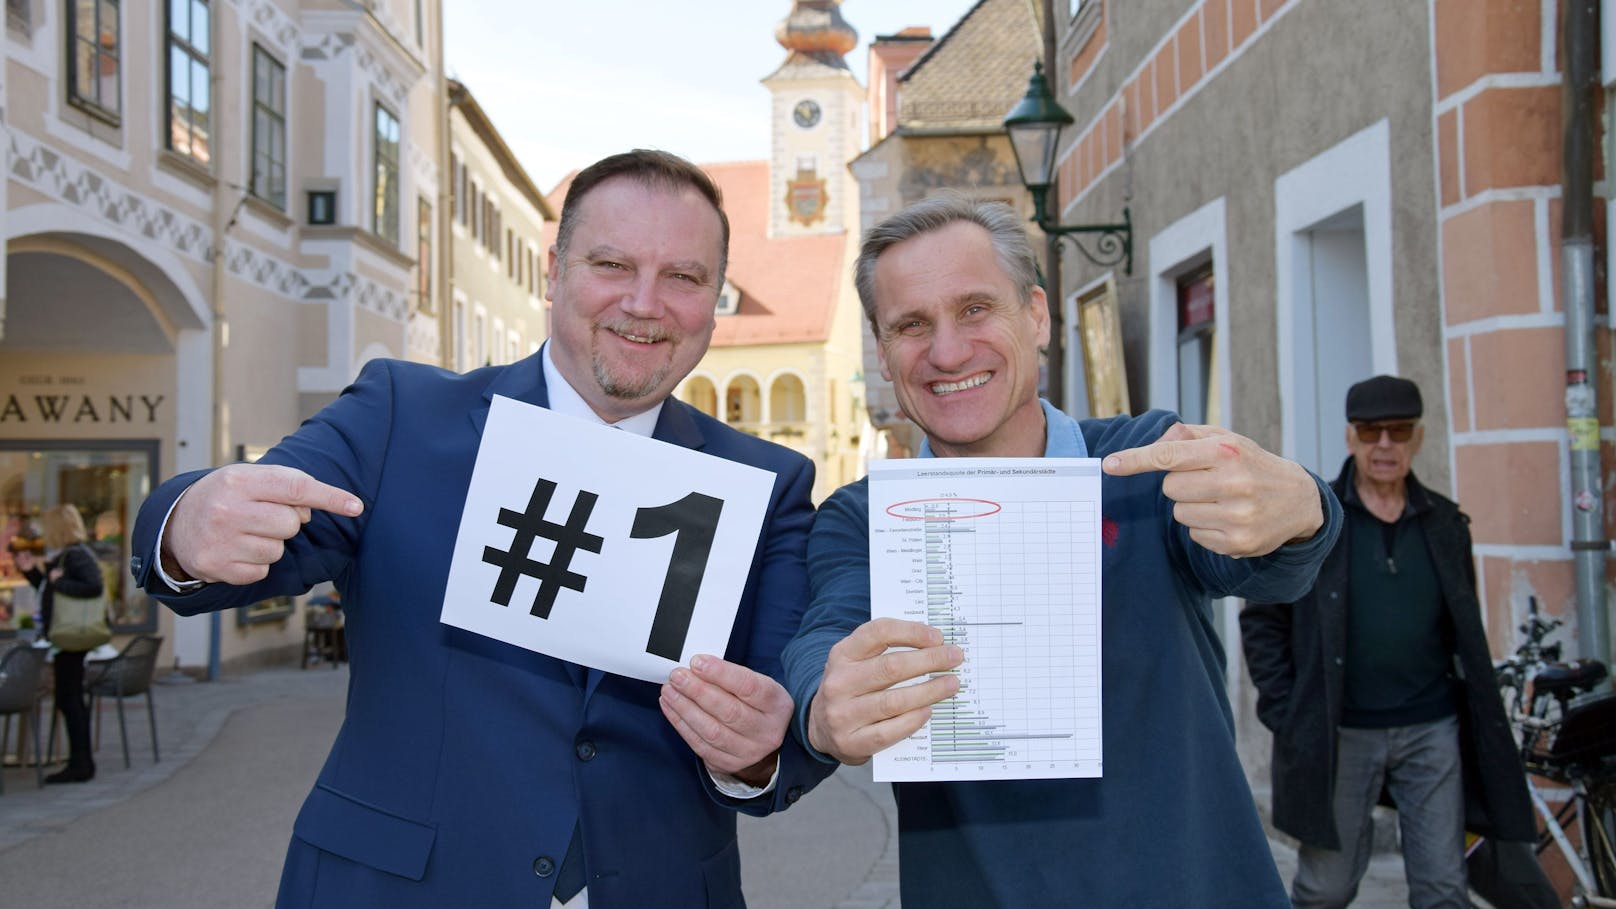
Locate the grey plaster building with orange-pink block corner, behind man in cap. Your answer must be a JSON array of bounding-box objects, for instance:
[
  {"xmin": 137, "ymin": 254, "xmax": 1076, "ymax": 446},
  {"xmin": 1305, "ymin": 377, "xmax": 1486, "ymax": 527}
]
[{"xmin": 1054, "ymin": 0, "xmax": 1613, "ymax": 892}]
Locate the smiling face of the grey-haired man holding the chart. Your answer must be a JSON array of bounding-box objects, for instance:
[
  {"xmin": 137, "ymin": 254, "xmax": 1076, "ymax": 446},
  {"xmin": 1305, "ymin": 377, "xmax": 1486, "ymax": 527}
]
[{"xmin": 874, "ymin": 222, "xmax": 1049, "ymax": 458}]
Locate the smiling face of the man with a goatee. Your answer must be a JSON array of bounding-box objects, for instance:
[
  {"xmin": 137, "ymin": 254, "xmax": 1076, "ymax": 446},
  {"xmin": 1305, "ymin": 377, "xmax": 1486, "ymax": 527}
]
[{"xmin": 545, "ymin": 176, "xmax": 722, "ymax": 422}]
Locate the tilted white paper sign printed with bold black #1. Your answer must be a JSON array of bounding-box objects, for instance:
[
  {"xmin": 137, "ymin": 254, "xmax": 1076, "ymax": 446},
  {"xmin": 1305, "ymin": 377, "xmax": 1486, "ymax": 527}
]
[{"xmin": 441, "ymin": 396, "xmax": 774, "ymax": 683}]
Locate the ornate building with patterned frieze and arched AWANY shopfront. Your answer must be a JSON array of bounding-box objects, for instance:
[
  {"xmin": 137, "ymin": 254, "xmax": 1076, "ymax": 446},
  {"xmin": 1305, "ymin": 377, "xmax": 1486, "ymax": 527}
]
[{"xmin": 0, "ymin": 0, "xmax": 449, "ymax": 666}]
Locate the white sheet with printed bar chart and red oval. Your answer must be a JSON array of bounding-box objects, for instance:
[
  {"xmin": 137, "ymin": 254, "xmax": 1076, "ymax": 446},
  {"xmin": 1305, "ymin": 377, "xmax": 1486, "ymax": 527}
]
[{"xmin": 869, "ymin": 458, "xmax": 1100, "ymax": 783}]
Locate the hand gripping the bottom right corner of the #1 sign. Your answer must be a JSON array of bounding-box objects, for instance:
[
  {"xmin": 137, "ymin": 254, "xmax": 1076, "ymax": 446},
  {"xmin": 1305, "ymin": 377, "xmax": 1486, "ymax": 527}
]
[{"xmin": 661, "ymin": 653, "xmax": 792, "ymax": 786}]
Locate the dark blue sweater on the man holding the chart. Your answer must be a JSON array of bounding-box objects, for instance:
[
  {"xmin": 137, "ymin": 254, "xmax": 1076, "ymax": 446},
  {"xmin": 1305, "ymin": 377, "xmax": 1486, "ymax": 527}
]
[{"xmin": 784, "ymin": 403, "xmax": 1341, "ymax": 909}]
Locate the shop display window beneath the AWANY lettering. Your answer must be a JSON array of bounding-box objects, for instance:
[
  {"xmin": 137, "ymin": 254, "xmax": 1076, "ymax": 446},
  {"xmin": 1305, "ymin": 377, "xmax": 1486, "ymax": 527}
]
[{"xmin": 0, "ymin": 440, "xmax": 158, "ymax": 637}]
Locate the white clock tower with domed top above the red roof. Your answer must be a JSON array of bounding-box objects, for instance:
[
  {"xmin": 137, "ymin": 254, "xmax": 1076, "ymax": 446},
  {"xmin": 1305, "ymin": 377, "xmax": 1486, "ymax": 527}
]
[{"xmin": 763, "ymin": 0, "xmax": 865, "ymax": 236}]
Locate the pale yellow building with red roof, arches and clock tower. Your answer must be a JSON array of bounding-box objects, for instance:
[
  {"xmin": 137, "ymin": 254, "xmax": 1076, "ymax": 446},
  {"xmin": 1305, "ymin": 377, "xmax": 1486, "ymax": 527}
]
[{"xmin": 675, "ymin": 0, "xmax": 871, "ymax": 501}]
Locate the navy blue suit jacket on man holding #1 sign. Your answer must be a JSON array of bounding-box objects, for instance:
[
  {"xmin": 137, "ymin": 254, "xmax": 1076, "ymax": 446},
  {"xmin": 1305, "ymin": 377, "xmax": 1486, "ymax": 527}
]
[{"xmin": 134, "ymin": 354, "xmax": 829, "ymax": 909}]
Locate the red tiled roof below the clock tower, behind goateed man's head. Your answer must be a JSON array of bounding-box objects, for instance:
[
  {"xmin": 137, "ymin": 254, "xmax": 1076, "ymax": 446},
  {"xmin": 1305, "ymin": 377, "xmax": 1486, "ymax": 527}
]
[{"xmin": 545, "ymin": 162, "xmax": 850, "ymax": 348}]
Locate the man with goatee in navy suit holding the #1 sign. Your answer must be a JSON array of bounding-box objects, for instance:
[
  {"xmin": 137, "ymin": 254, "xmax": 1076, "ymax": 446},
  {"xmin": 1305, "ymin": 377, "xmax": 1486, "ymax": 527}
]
[{"xmin": 134, "ymin": 150, "xmax": 829, "ymax": 909}]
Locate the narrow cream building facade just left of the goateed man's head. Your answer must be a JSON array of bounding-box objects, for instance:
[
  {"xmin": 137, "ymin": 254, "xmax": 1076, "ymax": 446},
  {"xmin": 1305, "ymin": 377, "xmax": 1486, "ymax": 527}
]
[{"xmin": 441, "ymin": 79, "xmax": 556, "ymax": 372}]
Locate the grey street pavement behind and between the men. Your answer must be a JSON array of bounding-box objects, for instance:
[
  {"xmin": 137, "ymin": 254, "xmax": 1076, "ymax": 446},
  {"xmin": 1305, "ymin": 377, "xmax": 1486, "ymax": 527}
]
[{"xmin": 0, "ymin": 665, "xmax": 1406, "ymax": 909}]
